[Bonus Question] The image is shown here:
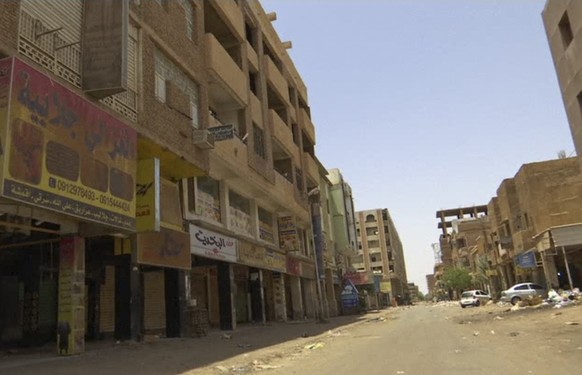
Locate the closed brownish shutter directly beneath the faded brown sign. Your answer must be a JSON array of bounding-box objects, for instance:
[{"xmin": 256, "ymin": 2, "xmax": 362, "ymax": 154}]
[{"xmin": 143, "ymin": 271, "xmax": 166, "ymax": 332}]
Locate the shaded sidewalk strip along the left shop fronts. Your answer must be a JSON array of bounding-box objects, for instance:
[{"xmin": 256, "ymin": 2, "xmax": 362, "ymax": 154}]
[{"xmin": 0, "ymin": 309, "xmax": 394, "ymax": 374}]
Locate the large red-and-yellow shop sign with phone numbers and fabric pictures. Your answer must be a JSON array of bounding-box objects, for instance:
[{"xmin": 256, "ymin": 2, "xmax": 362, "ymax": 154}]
[{"xmin": 0, "ymin": 58, "xmax": 137, "ymax": 230}]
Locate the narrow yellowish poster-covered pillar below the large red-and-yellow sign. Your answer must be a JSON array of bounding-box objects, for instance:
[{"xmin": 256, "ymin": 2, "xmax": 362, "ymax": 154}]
[{"xmin": 57, "ymin": 237, "xmax": 85, "ymax": 355}]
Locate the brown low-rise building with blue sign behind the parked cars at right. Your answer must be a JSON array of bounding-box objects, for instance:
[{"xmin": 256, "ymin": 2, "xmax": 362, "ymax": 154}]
[{"xmin": 489, "ymin": 158, "xmax": 582, "ymax": 287}]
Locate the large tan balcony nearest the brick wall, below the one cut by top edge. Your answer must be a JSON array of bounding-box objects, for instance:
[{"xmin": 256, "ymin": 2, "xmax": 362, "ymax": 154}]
[{"xmin": 206, "ymin": 33, "xmax": 247, "ymax": 110}]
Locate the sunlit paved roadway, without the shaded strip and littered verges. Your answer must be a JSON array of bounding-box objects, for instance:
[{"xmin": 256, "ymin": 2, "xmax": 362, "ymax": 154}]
[{"xmin": 270, "ymin": 306, "xmax": 582, "ymax": 375}]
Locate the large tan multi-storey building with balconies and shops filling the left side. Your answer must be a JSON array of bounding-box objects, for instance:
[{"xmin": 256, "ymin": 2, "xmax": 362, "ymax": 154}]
[{"xmin": 0, "ymin": 0, "xmax": 326, "ymax": 353}]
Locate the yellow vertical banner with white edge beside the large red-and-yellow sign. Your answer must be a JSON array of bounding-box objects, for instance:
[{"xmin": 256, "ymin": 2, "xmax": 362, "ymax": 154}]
[{"xmin": 135, "ymin": 158, "xmax": 160, "ymax": 232}]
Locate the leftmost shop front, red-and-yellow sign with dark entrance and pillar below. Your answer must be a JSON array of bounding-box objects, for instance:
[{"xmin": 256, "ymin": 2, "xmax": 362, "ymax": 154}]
[{"xmin": 0, "ymin": 58, "xmax": 137, "ymax": 354}]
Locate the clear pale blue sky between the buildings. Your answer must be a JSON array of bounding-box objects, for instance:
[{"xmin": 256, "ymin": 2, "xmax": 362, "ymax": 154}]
[{"xmin": 261, "ymin": 0, "xmax": 574, "ymax": 292}]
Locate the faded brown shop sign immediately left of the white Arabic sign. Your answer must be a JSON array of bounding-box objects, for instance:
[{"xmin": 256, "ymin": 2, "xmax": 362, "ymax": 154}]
[{"xmin": 137, "ymin": 228, "xmax": 192, "ymax": 270}]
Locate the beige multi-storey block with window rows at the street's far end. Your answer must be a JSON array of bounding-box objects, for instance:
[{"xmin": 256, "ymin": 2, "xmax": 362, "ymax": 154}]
[{"xmin": 352, "ymin": 209, "xmax": 408, "ymax": 305}]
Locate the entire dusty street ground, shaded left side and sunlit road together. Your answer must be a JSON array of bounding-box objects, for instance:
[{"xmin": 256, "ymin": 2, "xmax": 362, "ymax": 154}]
[{"xmin": 0, "ymin": 303, "xmax": 582, "ymax": 375}]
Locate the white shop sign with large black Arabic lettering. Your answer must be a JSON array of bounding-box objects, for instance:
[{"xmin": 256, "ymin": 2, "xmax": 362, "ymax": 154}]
[{"xmin": 190, "ymin": 224, "xmax": 236, "ymax": 263}]
